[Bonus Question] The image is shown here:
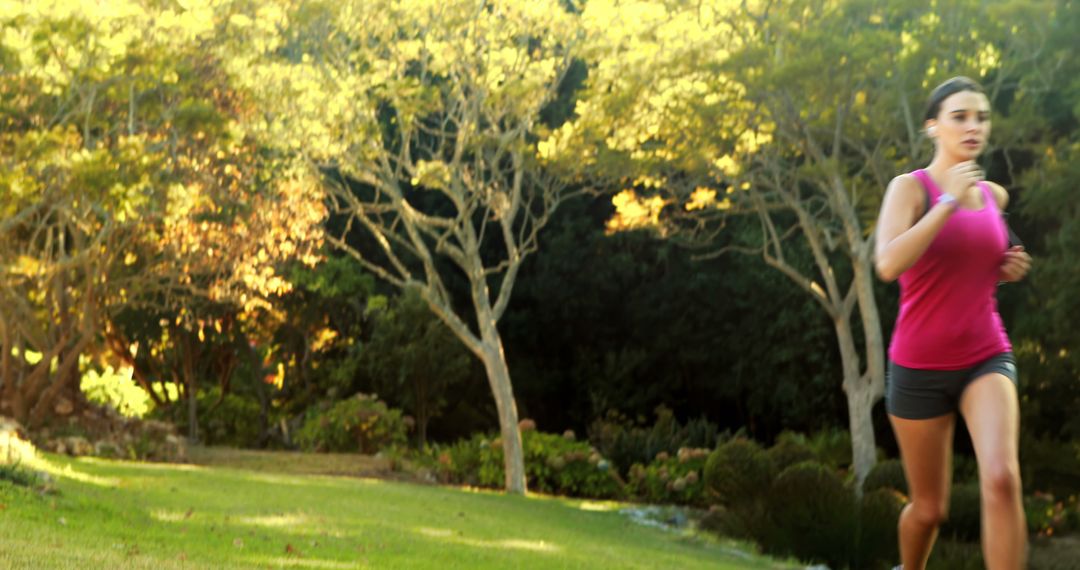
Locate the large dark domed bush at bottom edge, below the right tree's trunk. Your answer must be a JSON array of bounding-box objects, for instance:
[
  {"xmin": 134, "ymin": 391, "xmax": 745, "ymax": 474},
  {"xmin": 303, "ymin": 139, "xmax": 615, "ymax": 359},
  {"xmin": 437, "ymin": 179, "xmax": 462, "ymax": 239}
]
[{"xmin": 761, "ymin": 461, "xmax": 856, "ymax": 568}]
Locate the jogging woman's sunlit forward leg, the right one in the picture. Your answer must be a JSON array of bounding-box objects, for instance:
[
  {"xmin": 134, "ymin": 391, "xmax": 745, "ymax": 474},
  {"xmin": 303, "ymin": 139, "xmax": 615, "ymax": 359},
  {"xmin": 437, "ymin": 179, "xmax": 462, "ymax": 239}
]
[{"xmin": 960, "ymin": 374, "xmax": 1027, "ymax": 570}]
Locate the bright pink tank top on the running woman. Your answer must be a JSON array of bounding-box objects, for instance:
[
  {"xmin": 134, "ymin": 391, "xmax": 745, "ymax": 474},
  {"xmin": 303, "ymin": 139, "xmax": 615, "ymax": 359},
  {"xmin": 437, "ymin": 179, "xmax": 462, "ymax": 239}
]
[{"xmin": 889, "ymin": 169, "xmax": 1012, "ymax": 370}]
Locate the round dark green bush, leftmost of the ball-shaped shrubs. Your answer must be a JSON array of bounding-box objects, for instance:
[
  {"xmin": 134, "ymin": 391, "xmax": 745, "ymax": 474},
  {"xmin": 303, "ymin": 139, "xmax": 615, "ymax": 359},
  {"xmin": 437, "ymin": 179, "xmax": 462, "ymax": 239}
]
[{"xmin": 705, "ymin": 438, "xmax": 775, "ymax": 507}]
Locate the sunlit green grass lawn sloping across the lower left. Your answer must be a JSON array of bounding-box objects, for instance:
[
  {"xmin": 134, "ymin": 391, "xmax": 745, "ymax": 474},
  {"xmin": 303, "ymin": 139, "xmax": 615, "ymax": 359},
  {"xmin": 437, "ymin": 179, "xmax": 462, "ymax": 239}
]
[{"xmin": 0, "ymin": 454, "xmax": 791, "ymax": 570}]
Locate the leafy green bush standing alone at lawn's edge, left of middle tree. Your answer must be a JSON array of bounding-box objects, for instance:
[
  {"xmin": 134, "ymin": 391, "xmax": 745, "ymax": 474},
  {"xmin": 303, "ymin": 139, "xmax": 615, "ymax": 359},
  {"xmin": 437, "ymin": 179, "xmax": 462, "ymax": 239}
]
[{"xmin": 296, "ymin": 394, "xmax": 407, "ymax": 454}]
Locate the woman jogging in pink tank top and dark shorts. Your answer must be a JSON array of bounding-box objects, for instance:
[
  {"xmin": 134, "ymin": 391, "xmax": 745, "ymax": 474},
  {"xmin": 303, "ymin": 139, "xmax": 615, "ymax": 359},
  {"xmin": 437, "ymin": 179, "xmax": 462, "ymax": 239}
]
[{"xmin": 875, "ymin": 77, "xmax": 1031, "ymax": 570}]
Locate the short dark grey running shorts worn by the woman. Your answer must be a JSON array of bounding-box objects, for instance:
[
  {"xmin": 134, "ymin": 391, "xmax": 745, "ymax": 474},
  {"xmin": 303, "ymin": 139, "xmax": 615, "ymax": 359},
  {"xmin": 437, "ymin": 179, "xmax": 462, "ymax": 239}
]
[{"xmin": 885, "ymin": 352, "xmax": 1020, "ymax": 420}]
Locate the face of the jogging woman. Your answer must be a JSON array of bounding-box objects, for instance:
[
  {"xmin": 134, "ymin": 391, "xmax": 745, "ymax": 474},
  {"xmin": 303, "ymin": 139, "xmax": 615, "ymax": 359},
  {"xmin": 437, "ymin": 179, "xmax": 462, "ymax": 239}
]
[{"xmin": 927, "ymin": 91, "xmax": 990, "ymax": 160}]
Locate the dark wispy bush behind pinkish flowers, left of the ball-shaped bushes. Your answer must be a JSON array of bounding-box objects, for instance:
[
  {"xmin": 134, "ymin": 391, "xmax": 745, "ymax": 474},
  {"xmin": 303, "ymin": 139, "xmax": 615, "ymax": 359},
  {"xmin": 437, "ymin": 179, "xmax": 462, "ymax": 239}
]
[{"xmin": 589, "ymin": 404, "xmax": 726, "ymax": 475}]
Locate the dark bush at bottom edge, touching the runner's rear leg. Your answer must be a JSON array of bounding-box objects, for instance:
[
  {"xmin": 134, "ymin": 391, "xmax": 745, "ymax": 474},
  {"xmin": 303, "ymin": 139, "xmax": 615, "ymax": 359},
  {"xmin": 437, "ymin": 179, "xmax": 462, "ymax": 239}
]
[{"xmin": 852, "ymin": 488, "xmax": 904, "ymax": 568}]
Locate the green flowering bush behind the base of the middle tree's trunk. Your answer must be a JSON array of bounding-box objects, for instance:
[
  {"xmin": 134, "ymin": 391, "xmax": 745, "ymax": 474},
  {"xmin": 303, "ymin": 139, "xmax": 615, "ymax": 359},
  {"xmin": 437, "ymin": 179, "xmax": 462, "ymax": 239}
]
[{"xmin": 430, "ymin": 430, "xmax": 623, "ymax": 499}]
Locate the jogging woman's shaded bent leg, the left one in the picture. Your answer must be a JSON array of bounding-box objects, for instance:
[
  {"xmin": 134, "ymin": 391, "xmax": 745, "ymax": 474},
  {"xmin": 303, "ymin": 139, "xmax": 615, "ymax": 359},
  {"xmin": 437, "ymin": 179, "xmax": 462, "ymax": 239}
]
[{"xmin": 889, "ymin": 413, "xmax": 956, "ymax": 570}]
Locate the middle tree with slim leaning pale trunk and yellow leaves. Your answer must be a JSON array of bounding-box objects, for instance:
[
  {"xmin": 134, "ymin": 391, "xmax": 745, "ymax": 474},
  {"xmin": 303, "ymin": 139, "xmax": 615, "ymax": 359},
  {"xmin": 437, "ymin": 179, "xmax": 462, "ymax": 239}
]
[{"xmin": 230, "ymin": 0, "xmax": 578, "ymax": 493}]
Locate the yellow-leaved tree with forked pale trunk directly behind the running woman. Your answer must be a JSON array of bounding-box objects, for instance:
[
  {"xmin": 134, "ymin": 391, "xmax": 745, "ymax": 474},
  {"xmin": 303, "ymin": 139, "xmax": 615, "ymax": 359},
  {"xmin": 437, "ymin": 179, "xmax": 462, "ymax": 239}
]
[{"xmin": 557, "ymin": 0, "xmax": 1054, "ymax": 481}]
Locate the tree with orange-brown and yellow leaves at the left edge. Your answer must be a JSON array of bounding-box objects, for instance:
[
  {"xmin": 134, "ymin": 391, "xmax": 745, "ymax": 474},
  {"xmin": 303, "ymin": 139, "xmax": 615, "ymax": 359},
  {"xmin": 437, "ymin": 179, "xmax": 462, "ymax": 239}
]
[{"xmin": 0, "ymin": 2, "xmax": 324, "ymax": 425}]
